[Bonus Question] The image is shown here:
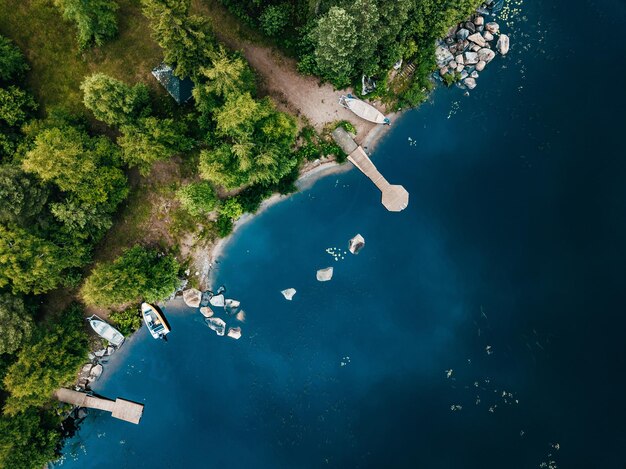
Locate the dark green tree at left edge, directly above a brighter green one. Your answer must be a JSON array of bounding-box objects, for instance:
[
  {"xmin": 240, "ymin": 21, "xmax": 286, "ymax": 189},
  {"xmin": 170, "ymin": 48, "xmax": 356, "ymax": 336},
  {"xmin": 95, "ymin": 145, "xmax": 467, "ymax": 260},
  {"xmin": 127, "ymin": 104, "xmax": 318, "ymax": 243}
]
[{"xmin": 0, "ymin": 164, "xmax": 48, "ymax": 222}]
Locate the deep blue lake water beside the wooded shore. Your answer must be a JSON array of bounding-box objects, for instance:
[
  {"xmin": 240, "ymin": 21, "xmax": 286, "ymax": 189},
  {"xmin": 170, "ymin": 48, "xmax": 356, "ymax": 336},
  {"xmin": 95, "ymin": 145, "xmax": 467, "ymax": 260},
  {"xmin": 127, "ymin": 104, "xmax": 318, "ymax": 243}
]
[{"xmin": 57, "ymin": 0, "xmax": 626, "ymax": 469}]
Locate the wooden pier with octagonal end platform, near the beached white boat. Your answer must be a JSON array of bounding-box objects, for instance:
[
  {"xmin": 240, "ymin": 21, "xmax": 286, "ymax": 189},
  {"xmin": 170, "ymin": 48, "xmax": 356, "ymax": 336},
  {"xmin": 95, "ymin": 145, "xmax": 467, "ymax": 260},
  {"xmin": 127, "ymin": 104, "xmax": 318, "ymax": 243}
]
[{"xmin": 333, "ymin": 127, "xmax": 409, "ymax": 212}]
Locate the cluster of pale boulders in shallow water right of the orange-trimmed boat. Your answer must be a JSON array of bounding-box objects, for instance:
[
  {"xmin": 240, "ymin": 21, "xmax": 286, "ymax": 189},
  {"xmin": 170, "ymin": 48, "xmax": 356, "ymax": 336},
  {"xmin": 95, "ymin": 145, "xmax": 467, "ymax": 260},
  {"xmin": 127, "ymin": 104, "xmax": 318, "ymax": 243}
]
[{"xmin": 183, "ymin": 286, "xmax": 246, "ymax": 339}]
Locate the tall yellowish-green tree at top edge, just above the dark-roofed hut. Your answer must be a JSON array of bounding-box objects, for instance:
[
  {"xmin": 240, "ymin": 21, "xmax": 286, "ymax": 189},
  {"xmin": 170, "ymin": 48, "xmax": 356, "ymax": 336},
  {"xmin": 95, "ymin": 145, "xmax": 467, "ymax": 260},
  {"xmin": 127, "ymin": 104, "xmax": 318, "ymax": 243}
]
[{"xmin": 142, "ymin": 0, "xmax": 214, "ymax": 78}]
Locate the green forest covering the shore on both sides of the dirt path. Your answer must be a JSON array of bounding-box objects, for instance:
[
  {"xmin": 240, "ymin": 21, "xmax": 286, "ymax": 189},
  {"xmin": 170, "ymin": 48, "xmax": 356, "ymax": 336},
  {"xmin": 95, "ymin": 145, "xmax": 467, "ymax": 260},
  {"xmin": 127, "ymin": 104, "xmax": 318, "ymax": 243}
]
[{"xmin": 0, "ymin": 0, "xmax": 478, "ymax": 468}]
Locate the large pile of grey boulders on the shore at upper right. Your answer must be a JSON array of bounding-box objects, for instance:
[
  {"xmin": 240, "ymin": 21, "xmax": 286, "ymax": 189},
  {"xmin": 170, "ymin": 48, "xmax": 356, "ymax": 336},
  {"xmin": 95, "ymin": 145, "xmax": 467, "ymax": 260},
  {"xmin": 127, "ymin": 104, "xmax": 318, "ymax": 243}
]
[{"xmin": 435, "ymin": 15, "xmax": 509, "ymax": 90}]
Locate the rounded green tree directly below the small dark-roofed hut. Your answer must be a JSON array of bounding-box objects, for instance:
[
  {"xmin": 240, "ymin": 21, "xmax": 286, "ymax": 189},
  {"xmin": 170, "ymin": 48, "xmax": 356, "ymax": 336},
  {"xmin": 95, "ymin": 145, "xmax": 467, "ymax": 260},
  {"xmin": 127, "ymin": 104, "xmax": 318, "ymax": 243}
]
[{"xmin": 117, "ymin": 117, "xmax": 193, "ymax": 175}]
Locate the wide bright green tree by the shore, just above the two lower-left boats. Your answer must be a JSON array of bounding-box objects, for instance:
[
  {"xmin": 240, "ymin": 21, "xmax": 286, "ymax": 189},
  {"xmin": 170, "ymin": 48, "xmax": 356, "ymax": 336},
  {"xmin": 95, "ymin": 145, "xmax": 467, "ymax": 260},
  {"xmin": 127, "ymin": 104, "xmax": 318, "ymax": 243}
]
[{"xmin": 81, "ymin": 246, "xmax": 180, "ymax": 306}]
